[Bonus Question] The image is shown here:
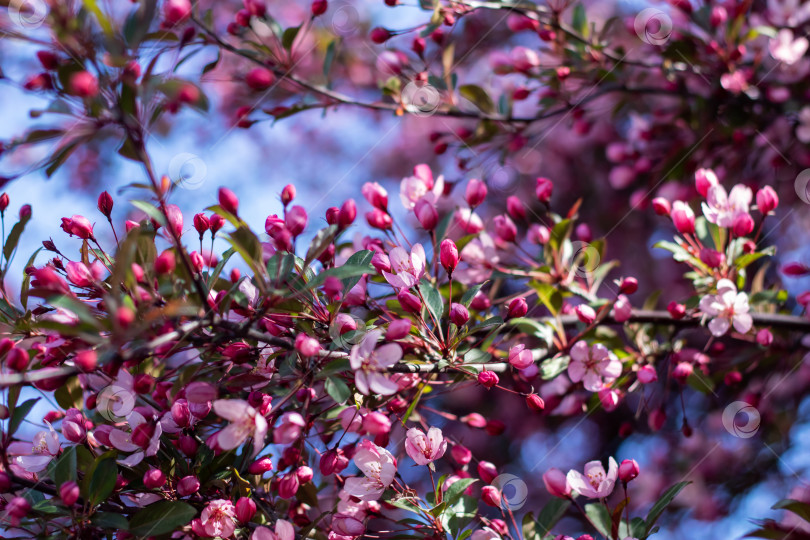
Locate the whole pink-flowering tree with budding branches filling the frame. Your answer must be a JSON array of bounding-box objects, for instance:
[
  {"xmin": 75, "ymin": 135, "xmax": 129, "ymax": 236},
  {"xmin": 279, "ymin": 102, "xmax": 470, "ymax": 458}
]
[{"xmin": 0, "ymin": 0, "xmax": 810, "ymax": 540}]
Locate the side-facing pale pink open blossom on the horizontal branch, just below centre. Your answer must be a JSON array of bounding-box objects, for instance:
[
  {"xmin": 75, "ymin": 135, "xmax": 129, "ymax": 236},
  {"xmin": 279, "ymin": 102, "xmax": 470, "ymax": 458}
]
[{"xmin": 349, "ymin": 330, "xmax": 402, "ymax": 396}]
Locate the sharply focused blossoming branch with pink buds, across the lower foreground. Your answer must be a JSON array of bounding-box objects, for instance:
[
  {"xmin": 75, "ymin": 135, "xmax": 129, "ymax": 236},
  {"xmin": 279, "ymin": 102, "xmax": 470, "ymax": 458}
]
[{"xmin": 0, "ymin": 149, "xmax": 808, "ymax": 540}]
